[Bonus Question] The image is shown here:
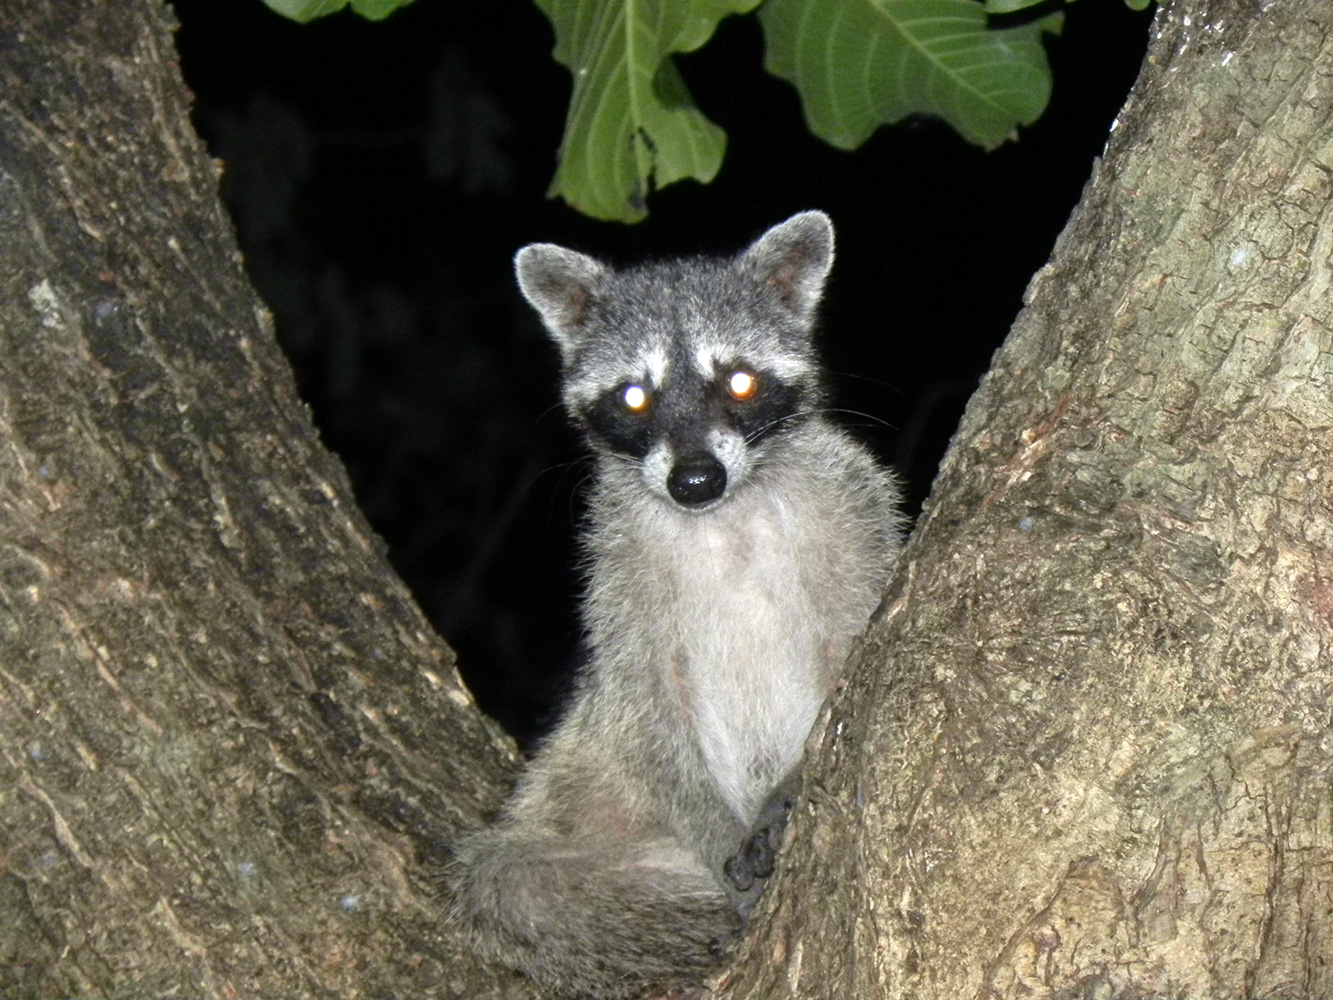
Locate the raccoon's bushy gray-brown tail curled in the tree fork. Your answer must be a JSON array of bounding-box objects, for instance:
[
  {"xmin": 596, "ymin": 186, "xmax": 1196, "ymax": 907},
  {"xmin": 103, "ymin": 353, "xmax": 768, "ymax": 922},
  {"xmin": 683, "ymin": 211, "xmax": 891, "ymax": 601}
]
[{"xmin": 447, "ymin": 825, "xmax": 740, "ymax": 1000}]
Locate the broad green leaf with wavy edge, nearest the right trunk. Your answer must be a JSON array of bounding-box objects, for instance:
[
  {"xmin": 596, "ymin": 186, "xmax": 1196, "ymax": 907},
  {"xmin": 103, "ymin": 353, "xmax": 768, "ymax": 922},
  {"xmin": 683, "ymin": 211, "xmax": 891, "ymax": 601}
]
[{"xmin": 758, "ymin": 0, "xmax": 1060, "ymax": 149}]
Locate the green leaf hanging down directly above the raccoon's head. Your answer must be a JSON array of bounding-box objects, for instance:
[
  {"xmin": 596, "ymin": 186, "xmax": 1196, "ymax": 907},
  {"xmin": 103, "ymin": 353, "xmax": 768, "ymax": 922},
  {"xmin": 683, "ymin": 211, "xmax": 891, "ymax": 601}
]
[{"xmin": 537, "ymin": 0, "xmax": 760, "ymax": 223}]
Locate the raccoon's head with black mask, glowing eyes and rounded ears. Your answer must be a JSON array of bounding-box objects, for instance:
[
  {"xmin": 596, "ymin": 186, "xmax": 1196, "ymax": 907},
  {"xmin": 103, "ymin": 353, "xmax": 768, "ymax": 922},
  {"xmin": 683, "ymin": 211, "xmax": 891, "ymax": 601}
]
[{"xmin": 515, "ymin": 212, "xmax": 833, "ymax": 509}]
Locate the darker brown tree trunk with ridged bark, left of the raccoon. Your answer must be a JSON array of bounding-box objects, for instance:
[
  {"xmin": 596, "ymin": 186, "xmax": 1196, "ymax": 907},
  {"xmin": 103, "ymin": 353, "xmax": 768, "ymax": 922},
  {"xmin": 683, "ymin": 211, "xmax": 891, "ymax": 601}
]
[{"xmin": 0, "ymin": 0, "xmax": 515, "ymax": 997}]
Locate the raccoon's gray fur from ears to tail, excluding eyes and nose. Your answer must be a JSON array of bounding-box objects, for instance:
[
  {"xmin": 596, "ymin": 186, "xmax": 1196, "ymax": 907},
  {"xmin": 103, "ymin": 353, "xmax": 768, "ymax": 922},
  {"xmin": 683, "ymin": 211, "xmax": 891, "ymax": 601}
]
[{"xmin": 449, "ymin": 212, "xmax": 900, "ymax": 1000}]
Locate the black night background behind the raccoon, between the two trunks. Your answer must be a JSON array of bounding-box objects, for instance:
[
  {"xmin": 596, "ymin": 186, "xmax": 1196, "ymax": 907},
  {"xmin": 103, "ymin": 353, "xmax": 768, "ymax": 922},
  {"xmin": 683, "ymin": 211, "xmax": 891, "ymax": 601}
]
[{"xmin": 173, "ymin": 0, "xmax": 1150, "ymax": 737}]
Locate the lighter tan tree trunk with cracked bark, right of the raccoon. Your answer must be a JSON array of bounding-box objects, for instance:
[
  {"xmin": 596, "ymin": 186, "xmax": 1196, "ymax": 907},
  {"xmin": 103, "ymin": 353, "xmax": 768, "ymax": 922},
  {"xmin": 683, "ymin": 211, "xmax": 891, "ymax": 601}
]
[{"xmin": 722, "ymin": 0, "xmax": 1333, "ymax": 1000}]
